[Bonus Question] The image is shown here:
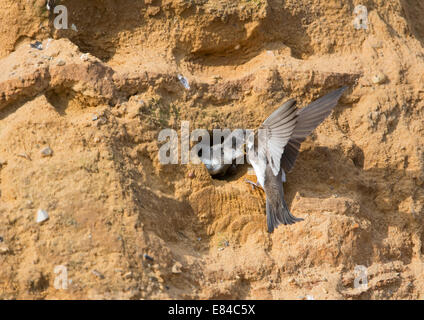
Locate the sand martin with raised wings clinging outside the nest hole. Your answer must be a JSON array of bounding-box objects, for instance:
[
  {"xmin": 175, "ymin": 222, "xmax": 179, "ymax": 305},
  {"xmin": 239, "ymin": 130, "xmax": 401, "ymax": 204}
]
[{"xmin": 246, "ymin": 87, "xmax": 346, "ymax": 233}]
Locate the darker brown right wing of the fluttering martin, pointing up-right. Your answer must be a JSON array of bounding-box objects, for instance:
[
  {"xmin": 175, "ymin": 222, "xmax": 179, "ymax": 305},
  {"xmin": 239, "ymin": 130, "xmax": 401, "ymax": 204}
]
[{"xmin": 281, "ymin": 87, "xmax": 347, "ymax": 172}]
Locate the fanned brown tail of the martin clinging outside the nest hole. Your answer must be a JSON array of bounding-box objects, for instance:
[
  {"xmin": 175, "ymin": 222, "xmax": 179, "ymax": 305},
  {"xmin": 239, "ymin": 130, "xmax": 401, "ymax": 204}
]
[{"xmin": 266, "ymin": 197, "xmax": 303, "ymax": 233}]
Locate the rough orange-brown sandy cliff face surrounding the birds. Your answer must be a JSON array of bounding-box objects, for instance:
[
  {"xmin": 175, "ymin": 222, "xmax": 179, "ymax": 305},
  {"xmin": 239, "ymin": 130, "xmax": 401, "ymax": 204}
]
[{"xmin": 0, "ymin": 0, "xmax": 424, "ymax": 299}]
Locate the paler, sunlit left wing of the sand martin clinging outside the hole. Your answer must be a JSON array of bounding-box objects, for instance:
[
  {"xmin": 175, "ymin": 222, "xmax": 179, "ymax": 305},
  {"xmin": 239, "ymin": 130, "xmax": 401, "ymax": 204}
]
[{"xmin": 258, "ymin": 99, "xmax": 298, "ymax": 176}]
